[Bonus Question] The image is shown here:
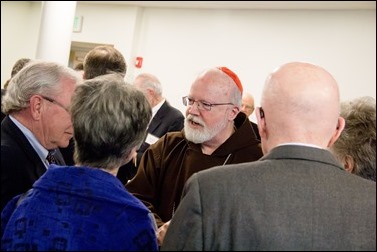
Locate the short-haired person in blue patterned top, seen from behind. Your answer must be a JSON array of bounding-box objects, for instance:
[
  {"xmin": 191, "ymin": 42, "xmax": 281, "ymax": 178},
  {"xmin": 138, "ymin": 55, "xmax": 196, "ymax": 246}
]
[{"xmin": 1, "ymin": 74, "xmax": 158, "ymax": 251}]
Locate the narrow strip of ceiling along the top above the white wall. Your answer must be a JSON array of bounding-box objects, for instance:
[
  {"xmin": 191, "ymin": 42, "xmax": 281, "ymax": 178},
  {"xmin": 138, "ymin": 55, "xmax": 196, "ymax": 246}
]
[{"xmin": 78, "ymin": 1, "xmax": 376, "ymax": 10}]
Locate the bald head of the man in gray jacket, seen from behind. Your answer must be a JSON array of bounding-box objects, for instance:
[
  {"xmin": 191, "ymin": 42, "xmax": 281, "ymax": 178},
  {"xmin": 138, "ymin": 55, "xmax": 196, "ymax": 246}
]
[{"xmin": 257, "ymin": 62, "xmax": 344, "ymax": 152}]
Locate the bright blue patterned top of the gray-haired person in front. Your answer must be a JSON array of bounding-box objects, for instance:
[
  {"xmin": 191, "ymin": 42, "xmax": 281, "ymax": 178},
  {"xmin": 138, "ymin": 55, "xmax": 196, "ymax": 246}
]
[{"xmin": 1, "ymin": 165, "xmax": 158, "ymax": 251}]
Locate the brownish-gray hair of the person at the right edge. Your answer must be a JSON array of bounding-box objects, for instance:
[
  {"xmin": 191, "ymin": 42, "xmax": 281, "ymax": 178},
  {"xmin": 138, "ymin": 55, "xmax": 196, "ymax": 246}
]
[{"xmin": 331, "ymin": 96, "xmax": 376, "ymax": 181}]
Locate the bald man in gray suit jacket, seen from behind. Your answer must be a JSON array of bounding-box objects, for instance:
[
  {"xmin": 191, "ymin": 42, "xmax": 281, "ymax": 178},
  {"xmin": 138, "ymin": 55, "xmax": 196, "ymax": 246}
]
[{"xmin": 161, "ymin": 62, "xmax": 376, "ymax": 251}]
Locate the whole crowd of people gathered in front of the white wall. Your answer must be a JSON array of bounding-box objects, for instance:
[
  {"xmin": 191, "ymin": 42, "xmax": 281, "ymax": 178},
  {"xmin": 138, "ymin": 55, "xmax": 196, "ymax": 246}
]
[{"xmin": 1, "ymin": 46, "xmax": 376, "ymax": 251}]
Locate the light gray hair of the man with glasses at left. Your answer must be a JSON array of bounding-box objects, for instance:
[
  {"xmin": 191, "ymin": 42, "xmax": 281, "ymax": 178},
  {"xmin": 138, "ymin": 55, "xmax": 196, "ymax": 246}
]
[{"xmin": 1, "ymin": 60, "xmax": 81, "ymax": 114}]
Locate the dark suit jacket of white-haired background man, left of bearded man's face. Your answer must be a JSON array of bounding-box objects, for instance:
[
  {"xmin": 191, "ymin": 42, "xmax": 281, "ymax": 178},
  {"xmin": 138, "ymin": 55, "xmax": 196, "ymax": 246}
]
[{"xmin": 117, "ymin": 101, "xmax": 185, "ymax": 184}]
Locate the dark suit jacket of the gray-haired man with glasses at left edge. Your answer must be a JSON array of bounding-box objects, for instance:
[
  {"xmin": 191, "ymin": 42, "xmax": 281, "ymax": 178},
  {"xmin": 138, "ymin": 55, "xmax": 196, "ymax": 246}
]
[{"xmin": 1, "ymin": 116, "xmax": 65, "ymax": 210}]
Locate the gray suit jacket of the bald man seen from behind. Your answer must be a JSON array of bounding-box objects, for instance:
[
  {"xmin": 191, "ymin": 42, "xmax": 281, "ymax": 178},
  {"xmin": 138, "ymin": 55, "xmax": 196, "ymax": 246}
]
[{"xmin": 162, "ymin": 145, "xmax": 376, "ymax": 251}]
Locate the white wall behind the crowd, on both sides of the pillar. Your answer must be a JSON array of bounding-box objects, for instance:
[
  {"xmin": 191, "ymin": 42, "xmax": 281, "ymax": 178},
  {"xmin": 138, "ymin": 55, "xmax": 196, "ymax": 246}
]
[{"xmin": 1, "ymin": 2, "xmax": 376, "ymax": 118}]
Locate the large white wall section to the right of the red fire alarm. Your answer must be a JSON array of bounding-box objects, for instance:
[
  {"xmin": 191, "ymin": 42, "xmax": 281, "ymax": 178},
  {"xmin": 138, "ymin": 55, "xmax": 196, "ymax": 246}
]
[{"xmin": 135, "ymin": 9, "xmax": 376, "ymax": 116}]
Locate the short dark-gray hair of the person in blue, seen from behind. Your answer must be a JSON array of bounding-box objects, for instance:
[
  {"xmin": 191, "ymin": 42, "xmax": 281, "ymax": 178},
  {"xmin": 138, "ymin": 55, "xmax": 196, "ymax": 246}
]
[{"xmin": 71, "ymin": 74, "xmax": 152, "ymax": 169}]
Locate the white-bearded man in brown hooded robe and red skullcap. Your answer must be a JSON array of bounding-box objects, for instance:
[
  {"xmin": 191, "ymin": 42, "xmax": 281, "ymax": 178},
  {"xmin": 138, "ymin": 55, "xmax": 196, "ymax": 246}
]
[{"xmin": 126, "ymin": 67, "xmax": 263, "ymax": 245}]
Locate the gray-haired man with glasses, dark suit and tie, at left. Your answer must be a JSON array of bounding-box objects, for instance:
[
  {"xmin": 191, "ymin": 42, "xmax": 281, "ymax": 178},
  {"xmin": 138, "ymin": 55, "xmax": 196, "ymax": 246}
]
[{"xmin": 1, "ymin": 61, "xmax": 81, "ymax": 209}]
